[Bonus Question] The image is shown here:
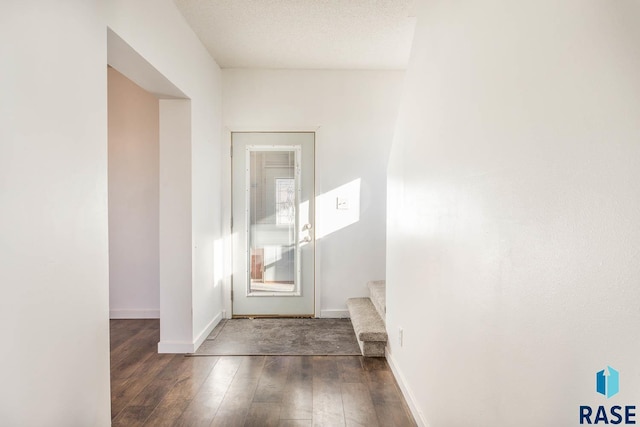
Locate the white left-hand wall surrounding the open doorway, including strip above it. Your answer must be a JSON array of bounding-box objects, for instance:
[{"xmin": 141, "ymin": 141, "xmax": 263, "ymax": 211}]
[{"xmin": 0, "ymin": 0, "xmax": 221, "ymax": 426}]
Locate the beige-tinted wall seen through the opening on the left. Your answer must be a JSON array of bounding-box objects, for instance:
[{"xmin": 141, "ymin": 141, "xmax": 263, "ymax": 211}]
[{"xmin": 107, "ymin": 68, "xmax": 160, "ymax": 319}]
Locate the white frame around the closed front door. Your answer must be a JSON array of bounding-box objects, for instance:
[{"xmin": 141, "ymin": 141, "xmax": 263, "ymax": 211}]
[{"xmin": 222, "ymin": 125, "xmax": 322, "ymax": 319}]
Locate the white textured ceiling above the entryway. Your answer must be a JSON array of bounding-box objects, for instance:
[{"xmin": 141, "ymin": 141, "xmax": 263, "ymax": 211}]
[{"xmin": 174, "ymin": 0, "xmax": 415, "ymax": 69}]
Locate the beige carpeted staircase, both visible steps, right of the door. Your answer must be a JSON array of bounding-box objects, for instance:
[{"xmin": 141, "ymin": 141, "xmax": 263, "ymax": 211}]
[{"xmin": 347, "ymin": 280, "xmax": 387, "ymax": 357}]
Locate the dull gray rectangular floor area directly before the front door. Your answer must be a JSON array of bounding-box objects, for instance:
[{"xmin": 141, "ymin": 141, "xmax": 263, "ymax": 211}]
[{"xmin": 193, "ymin": 319, "xmax": 360, "ymax": 356}]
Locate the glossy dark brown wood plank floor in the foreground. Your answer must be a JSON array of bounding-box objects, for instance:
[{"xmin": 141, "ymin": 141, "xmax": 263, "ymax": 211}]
[{"xmin": 111, "ymin": 320, "xmax": 416, "ymax": 427}]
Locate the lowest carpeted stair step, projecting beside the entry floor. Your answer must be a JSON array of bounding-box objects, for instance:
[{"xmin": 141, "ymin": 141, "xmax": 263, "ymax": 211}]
[{"xmin": 347, "ymin": 298, "xmax": 387, "ymax": 357}]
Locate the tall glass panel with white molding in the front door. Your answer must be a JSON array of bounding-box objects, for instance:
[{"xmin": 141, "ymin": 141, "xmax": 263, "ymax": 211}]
[{"xmin": 247, "ymin": 146, "xmax": 300, "ymax": 296}]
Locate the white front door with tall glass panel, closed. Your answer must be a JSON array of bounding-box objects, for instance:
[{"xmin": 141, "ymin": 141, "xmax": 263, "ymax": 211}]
[{"xmin": 231, "ymin": 132, "xmax": 315, "ymax": 316}]
